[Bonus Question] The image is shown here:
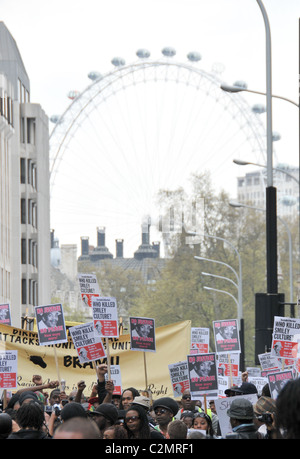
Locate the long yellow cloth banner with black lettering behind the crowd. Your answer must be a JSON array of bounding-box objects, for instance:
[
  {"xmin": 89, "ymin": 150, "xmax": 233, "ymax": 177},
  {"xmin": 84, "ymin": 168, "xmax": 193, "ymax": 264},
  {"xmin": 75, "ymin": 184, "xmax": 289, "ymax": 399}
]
[{"xmin": 0, "ymin": 321, "xmax": 191, "ymax": 399}]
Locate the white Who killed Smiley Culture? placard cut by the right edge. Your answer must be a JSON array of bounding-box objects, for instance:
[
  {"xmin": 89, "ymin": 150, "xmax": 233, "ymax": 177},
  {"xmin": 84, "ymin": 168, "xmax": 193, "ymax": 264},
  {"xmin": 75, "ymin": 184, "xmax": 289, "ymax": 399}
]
[{"xmin": 271, "ymin": 316, "xmax": 300, "ymax": 359}]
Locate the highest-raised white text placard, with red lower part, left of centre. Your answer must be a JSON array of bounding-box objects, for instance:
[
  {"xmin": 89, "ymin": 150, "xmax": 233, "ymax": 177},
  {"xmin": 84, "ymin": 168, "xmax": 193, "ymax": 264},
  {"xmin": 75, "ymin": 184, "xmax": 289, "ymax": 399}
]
[{"xmin": 92, "ymin": 297, "xmax": 119, "ymax": 338}]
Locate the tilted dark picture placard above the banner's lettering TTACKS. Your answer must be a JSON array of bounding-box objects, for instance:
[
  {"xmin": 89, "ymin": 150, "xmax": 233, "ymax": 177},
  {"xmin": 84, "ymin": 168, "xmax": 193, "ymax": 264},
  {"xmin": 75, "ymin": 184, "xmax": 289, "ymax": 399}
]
[{"xmin": 34, "ymin": 304, "xmax": 68, "ymax": 346}]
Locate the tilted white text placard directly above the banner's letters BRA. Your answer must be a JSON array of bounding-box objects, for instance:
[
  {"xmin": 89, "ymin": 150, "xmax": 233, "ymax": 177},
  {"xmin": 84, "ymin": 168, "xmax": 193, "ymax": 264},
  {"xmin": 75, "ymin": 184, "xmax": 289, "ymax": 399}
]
[{"xmin": 69, "ymin": 322, "xmax": 106, "ymax": 363}]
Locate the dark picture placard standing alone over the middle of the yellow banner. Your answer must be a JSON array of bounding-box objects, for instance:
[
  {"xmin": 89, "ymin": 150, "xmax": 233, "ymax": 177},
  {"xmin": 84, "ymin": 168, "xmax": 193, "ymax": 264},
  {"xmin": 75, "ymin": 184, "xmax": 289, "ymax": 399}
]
[{"xmin": 129, "ymin": 317, "xmax": 156, "ymax": 352}]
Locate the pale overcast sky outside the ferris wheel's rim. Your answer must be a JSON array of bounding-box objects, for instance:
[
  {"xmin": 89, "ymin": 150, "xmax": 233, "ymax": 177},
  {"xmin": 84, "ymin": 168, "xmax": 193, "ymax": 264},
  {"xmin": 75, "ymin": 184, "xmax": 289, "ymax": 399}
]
[{"xmin": 0, "ymin": 0, "xmax": 300, "ymax": 256}]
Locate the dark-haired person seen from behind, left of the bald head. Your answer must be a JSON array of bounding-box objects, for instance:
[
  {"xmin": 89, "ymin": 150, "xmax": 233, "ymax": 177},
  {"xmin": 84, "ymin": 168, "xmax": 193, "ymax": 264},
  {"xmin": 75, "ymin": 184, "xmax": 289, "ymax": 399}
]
[{"xmin": 8, "ymin": 401, "xmax": 51, "ymax": 440}]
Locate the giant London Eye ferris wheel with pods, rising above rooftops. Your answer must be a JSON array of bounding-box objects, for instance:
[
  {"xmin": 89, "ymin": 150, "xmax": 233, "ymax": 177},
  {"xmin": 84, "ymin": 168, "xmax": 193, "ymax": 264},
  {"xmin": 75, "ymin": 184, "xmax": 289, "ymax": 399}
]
[{"xmin": 50, "ymin": 47, "xmax": 266, "ymax": 257}]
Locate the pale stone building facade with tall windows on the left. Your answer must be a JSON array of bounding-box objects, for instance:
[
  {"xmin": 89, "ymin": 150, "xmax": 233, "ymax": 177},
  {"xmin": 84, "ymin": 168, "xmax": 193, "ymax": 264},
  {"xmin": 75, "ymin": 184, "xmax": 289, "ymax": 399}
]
[{"xmin": 0, "ymin": 22, "xmax": 50, "ymax": 327}]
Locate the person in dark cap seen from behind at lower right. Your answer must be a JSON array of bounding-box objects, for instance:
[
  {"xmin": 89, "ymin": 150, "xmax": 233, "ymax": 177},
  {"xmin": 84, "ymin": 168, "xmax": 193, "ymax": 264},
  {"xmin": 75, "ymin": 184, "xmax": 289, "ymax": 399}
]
[{"xmin": 226, "ymin": 397, "xmax": 262, "ymax": 439}]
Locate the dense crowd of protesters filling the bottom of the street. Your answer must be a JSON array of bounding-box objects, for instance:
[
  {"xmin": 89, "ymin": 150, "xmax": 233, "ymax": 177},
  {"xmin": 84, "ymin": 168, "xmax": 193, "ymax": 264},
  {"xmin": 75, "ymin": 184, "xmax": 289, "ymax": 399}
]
[{"xmin": 0, "ymin": 364, "xmax": 300, "ymax": 441}]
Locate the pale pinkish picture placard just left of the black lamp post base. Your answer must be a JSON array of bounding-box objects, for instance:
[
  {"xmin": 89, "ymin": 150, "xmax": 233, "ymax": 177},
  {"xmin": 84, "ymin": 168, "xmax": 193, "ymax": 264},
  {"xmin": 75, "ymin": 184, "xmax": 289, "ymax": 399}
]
[{"xmin": 213, "ymin": 319, "xmax": 241, "ymax": 354}]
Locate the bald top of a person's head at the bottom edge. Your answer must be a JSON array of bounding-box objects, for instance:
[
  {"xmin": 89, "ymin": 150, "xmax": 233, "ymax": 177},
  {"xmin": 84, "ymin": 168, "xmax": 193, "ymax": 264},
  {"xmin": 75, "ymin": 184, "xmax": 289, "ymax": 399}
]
[{"xmin": 53, "ymin": 417, "xmax": 100, "ymax": 440}]
